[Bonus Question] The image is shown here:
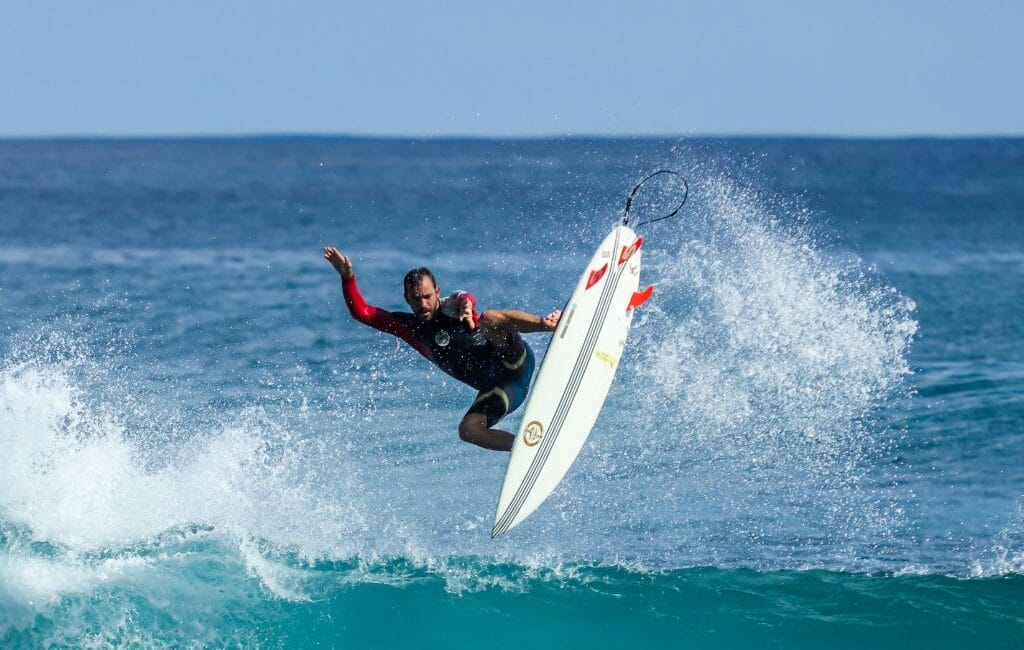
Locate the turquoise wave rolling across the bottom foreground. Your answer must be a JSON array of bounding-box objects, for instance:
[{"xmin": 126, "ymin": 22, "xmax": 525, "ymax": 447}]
[{"xmin": 0, "ymin": 525, "xmax": 1024, "ymax": 648}]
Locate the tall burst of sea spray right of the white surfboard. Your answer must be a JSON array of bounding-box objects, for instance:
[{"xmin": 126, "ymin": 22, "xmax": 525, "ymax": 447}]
[{"xmin": 614, "ymin": 175, "xmax": 918, "ymax": 565}]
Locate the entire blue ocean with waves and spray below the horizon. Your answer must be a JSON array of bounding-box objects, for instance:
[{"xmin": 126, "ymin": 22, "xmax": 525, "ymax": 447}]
[{"xmin": 0, "ymin": 138, "xmax": 1024, "ymax": 649}]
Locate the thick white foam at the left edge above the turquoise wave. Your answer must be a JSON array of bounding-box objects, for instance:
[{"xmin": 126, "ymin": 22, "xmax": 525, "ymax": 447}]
[{"xmin": 0, "ymin": 361, "xmax": 364, "ymax": 556}]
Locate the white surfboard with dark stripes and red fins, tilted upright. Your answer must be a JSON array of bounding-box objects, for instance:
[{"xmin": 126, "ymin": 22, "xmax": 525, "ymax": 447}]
[{"xmin": 490, "ymin": 225, "xmax": 653, "ymax": 537}]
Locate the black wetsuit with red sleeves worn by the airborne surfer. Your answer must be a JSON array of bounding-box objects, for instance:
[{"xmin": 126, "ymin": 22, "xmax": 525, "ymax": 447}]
[{"xmin": 342, "ymin": 274, "xmax": 534, "ymax": 427}]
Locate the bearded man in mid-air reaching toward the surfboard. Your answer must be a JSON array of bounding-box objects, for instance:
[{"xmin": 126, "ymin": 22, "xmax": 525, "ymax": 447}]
[{"xmin": 324, "ymin": 247, "xmax": 561, "ymax": 451}]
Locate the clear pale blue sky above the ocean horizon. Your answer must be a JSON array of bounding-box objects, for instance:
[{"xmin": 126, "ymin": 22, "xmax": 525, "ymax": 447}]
[{"xmin": 0, "ymin": 0, "xmax": 1024, "ymax": 137}]
